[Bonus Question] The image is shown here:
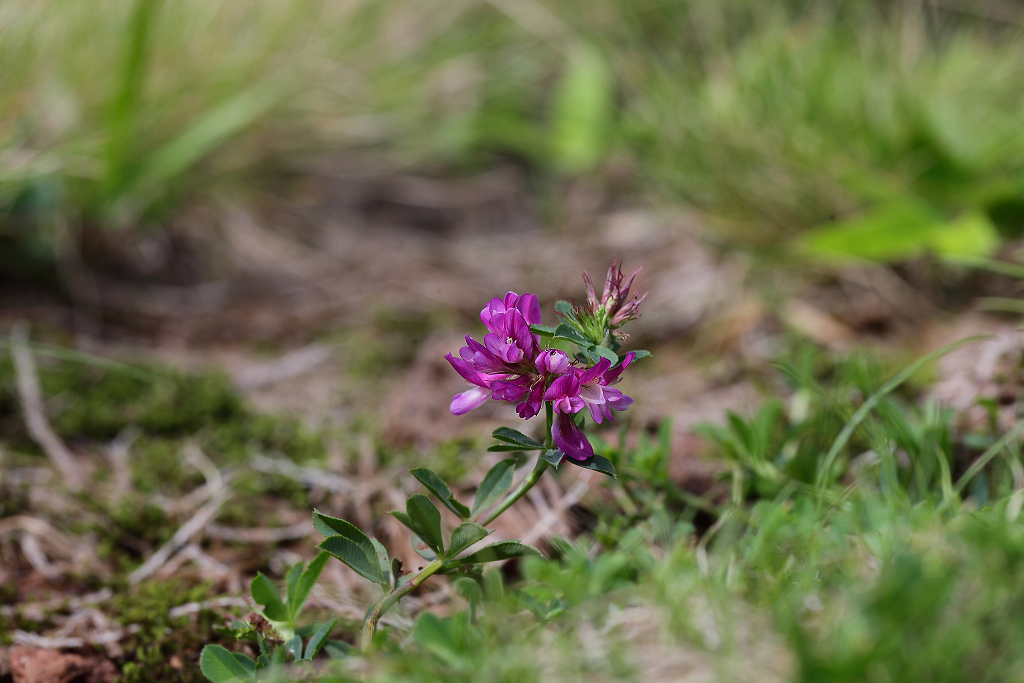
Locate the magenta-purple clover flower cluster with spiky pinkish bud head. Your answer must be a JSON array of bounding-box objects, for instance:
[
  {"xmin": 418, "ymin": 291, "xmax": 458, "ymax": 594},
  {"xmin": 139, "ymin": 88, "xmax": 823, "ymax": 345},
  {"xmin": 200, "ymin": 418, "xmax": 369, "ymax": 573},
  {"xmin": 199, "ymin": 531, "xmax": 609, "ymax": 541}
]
[{"xmin": 444, "ymin": 262, "xmax": 642, "ymax": 461}]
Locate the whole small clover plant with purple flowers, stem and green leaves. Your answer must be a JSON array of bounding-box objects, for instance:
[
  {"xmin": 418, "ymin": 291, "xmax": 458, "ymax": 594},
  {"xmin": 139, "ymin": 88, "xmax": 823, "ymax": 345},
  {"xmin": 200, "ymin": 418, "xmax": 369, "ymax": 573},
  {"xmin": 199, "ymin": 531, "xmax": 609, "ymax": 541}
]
[{"xmin": 201, "ymin": 261, "xmax": 649, "ymax": 671}]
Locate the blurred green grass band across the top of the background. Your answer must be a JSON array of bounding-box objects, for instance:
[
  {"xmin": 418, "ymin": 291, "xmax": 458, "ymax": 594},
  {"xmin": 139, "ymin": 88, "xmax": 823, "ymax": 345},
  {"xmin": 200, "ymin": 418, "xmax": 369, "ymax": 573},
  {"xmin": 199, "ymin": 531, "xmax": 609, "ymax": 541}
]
[{"xmin": 6, "ymin": 0, "xmax": 1024, "ymax": 270}]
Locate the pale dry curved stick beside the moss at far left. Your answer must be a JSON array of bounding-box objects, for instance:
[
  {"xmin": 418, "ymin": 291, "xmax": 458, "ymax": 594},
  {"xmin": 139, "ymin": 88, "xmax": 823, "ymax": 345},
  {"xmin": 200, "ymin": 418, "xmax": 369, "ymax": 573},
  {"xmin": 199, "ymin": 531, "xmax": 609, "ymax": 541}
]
[{"xmin": 10, "ymin": 323, "xmax": 82, "ymax": 490}]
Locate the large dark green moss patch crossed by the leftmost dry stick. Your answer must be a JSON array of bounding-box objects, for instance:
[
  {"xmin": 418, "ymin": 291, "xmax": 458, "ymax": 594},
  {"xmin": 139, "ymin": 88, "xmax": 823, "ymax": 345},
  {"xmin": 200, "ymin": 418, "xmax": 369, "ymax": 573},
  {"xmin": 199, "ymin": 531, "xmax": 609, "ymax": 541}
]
[{"xmin": 0, "ymin": 357, "xmax": 324, "ymax": 485}]
